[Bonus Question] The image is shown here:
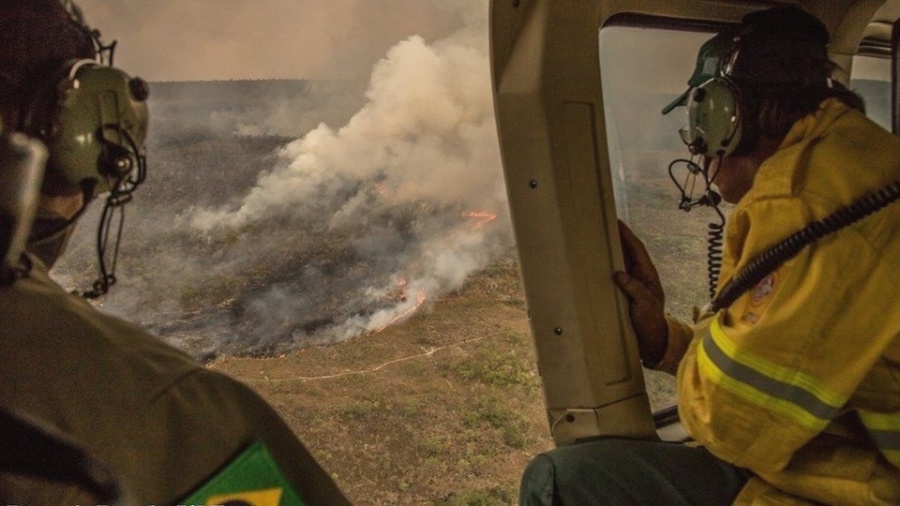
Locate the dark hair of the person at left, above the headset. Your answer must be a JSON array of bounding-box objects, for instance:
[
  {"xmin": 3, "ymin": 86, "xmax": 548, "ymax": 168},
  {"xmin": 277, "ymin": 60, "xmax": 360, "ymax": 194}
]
[{"xmin": 0, "ymin": 0, "xmax": 95, "ymax": 113}]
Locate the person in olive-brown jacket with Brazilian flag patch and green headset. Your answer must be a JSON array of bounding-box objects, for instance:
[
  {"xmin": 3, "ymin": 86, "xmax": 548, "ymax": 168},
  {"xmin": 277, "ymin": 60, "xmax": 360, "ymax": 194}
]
[{"xmin": 0, "ymin": 0, "xmax": 347, "ymax": 506}]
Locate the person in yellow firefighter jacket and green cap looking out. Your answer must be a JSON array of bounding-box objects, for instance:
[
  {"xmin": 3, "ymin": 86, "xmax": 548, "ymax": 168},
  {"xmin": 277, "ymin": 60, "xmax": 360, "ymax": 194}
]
[{"xmin": 521, "ymin": 7, "xmax": 900, "ymax": 505}]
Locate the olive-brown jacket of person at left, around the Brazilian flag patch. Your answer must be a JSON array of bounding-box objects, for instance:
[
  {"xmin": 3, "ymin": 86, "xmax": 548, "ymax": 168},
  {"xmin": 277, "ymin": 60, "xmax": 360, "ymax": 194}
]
[{"xmin": 0, "ymin": 257, "xmax": 348, "ymax": 505}]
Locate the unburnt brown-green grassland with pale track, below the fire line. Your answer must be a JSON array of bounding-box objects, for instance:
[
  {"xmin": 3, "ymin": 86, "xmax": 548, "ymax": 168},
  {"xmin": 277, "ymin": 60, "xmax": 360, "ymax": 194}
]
[{"xmin": 209, "ymin": 261, "xmax": 552, "ymax": 505}]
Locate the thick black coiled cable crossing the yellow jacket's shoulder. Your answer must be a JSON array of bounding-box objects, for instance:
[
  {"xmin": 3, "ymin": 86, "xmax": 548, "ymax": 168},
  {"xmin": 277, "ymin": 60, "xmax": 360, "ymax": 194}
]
[{"xmin": 710, "ymin": 181, "xmax": 900, "ymax": 312}]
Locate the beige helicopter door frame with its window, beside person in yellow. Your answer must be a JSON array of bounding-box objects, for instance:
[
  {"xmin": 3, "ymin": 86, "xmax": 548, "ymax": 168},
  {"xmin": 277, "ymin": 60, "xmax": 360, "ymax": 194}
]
[{"xmin": 490, "ymin": 0, "xmax": 900, "ymax": 445}]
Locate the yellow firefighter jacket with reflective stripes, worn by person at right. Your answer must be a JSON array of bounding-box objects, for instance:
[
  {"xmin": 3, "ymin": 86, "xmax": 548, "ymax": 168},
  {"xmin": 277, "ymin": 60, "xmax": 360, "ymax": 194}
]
[{"xmin": 661, "ymin": 99, "xmax": 900, "ymax": 505}]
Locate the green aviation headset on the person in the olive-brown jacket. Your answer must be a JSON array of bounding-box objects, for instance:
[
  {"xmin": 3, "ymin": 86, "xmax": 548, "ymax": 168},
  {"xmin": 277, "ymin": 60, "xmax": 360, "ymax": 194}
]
[{"xmin": 16, "ymin": 2, "xmax": 149, "ymax": 298}]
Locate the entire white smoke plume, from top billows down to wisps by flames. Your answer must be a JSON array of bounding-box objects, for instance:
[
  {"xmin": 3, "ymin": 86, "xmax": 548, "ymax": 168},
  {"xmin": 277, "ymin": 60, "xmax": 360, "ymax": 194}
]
[{"xmin": 174, "ymin": 2, "xmax": 509, "ymax": 350}]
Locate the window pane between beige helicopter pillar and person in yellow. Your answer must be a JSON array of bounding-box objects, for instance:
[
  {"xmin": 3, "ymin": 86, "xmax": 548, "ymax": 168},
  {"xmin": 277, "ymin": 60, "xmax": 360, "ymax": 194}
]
[{"xmin": 599, "ymin": 26, "xmax": 719, "ymax": 411}]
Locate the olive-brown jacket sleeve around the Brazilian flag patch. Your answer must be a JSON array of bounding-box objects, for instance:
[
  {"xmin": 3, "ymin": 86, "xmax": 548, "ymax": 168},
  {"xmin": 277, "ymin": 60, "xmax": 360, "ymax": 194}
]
[{"xmin": 139, "ymin": 369, "xmax": 350, "ymax": 505}]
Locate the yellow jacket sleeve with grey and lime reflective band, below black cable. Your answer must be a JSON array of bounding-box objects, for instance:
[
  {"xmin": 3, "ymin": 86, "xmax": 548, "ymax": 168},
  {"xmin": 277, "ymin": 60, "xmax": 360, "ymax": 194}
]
[{"xmin": 677, "ymin": 205, "xmax": 898, "ymax": 472}]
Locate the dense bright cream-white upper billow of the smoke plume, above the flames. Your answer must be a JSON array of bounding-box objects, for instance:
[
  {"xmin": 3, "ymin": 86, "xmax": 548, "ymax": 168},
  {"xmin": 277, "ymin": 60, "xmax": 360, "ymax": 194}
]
[{"xmin": 191, "ymin": 26, "xmax": 503, "ymax": 230}]
